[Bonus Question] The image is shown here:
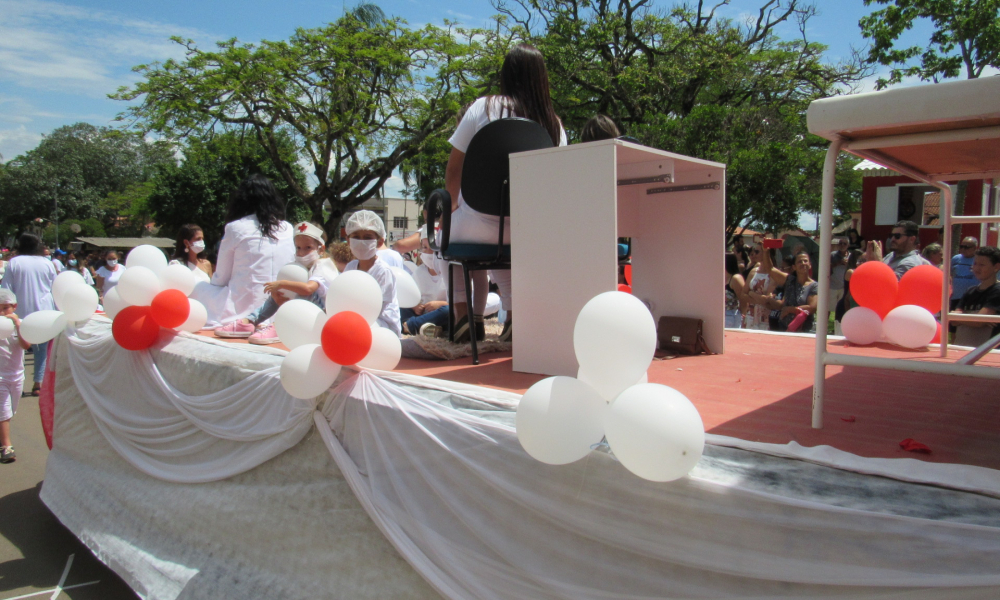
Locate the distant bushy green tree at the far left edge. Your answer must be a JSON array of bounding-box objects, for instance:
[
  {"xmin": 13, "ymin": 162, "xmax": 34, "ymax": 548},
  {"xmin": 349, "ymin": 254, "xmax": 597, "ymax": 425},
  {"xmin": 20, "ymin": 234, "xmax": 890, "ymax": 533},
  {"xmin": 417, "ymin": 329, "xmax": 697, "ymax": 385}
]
[{"xmin": 0, "ymin": 123, "xmax": 173, "ymax": 239}]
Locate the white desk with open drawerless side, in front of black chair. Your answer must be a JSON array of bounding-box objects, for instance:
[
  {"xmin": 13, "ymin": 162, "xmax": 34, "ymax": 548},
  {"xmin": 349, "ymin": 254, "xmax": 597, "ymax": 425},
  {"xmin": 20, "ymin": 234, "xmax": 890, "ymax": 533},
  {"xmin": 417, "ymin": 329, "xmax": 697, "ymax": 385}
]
[{"xmin": 510, "ymin": 140, "xmax": 726, "ymax": 377}]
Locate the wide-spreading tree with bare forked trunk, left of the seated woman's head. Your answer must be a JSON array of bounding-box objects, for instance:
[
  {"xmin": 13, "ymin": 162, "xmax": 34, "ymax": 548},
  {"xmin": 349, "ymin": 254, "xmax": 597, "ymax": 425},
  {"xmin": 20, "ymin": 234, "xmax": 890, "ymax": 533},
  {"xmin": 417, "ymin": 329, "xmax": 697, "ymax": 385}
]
[{"xmin": 111, "ymin": 7, "xmax": 479, "ymax": 234}]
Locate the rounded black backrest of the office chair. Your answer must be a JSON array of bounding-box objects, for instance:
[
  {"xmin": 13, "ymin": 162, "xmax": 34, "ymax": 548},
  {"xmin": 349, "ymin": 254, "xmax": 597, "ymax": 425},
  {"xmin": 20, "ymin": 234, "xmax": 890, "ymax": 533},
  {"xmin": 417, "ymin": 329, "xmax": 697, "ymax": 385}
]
[{"xmin": 462, "ymin": 117, "xmax": 554, "ymax": 216}]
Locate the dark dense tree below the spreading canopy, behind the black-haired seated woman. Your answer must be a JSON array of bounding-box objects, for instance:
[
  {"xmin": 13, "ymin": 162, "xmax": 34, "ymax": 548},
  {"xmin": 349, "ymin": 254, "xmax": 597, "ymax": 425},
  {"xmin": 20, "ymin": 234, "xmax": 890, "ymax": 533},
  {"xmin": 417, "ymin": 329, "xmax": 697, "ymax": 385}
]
[{"xmin": 147, "ymin": 132, "xmax": 309, "ymax": 248}]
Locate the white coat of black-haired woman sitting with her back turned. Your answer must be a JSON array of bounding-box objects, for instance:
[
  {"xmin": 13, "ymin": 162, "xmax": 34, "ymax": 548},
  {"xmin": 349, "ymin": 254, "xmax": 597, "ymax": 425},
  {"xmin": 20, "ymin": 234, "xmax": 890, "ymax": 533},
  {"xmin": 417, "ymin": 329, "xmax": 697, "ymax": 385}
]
[{"xmin": 191, "ymin": 215, "xmax": 295, "ymax": 327}]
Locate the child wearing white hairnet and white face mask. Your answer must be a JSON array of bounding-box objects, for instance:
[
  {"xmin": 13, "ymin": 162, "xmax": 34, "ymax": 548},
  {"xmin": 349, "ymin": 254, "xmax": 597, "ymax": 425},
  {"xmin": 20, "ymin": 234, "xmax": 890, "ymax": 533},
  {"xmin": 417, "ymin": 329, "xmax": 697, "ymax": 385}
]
[{"xmin": 344, "ymin": 210, "xmax": 402, "ymax": 336}]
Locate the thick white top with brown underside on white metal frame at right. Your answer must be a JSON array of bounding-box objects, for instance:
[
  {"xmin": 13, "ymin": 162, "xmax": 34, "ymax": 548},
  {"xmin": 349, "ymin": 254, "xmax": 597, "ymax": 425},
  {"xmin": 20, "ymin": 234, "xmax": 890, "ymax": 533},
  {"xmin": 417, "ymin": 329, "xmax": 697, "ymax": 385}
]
[{"xmin": 807, "ymin": 77, "xmax": 1000, "ymax": 180}]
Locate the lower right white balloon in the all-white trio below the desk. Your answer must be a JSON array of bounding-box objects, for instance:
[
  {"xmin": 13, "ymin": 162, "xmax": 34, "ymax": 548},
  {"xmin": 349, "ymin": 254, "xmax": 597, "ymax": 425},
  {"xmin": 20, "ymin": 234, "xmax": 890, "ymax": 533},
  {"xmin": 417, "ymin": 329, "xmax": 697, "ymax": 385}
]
[{"xmin": 604, "ymin": 383, "xmax": 705, "ymax": 481}]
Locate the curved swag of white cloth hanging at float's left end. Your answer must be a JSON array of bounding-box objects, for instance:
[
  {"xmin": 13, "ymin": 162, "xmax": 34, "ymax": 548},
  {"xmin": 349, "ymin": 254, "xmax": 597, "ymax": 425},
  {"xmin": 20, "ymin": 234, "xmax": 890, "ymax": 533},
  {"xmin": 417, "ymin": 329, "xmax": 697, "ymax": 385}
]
[{"xmin": 60, "ymin": 328, "xmax": 315, "ymax": 483}]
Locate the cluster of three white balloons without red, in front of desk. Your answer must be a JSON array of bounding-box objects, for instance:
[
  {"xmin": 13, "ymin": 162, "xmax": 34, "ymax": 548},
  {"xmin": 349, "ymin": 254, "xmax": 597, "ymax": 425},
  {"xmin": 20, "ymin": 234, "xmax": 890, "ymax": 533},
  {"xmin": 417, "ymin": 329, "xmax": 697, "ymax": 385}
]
[{"xmin": 516, "ymin": 292, "xmax": 705, "ymax": 481}]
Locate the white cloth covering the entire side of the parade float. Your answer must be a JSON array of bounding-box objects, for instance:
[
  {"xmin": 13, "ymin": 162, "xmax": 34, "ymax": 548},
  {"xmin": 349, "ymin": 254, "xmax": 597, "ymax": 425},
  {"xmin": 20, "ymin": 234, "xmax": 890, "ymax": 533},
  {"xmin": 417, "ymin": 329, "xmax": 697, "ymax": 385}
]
[{"xmin": 42, "ymin": 325, "xmax": 1000, "ymax": 600}]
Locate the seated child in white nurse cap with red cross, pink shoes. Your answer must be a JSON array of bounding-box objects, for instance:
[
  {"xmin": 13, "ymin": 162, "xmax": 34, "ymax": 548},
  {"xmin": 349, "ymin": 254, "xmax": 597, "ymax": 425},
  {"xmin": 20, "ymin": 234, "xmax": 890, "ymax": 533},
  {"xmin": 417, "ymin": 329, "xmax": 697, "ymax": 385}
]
[{"xmin": 215, "ymin": 222, "xmax": 337, "ymax": 344}]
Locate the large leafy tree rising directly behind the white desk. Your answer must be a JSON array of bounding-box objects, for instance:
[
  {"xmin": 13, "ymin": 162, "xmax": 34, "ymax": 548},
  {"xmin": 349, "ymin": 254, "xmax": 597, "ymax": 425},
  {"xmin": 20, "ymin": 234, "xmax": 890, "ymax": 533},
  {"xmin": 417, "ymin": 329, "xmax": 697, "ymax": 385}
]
[{"xmin": 494, "ymin": 0, "xmax": 867, "ymax": 236}]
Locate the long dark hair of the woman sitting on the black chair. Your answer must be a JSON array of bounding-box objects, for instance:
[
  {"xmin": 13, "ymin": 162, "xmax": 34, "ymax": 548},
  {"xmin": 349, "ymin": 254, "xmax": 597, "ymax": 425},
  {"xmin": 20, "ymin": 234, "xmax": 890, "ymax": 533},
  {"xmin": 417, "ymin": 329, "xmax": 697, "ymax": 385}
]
[{"xmin": 487, "ymin": 44, "xmax": 562, "ymax": 146}]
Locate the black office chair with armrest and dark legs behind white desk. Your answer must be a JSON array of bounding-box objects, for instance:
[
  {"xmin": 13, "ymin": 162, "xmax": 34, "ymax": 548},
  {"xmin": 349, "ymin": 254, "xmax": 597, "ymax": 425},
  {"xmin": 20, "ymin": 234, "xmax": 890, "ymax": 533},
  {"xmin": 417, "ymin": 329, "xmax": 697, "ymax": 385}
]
[{"xmin": 427, "ymin": 118, "xmax": 554, "ymax": 365}]
